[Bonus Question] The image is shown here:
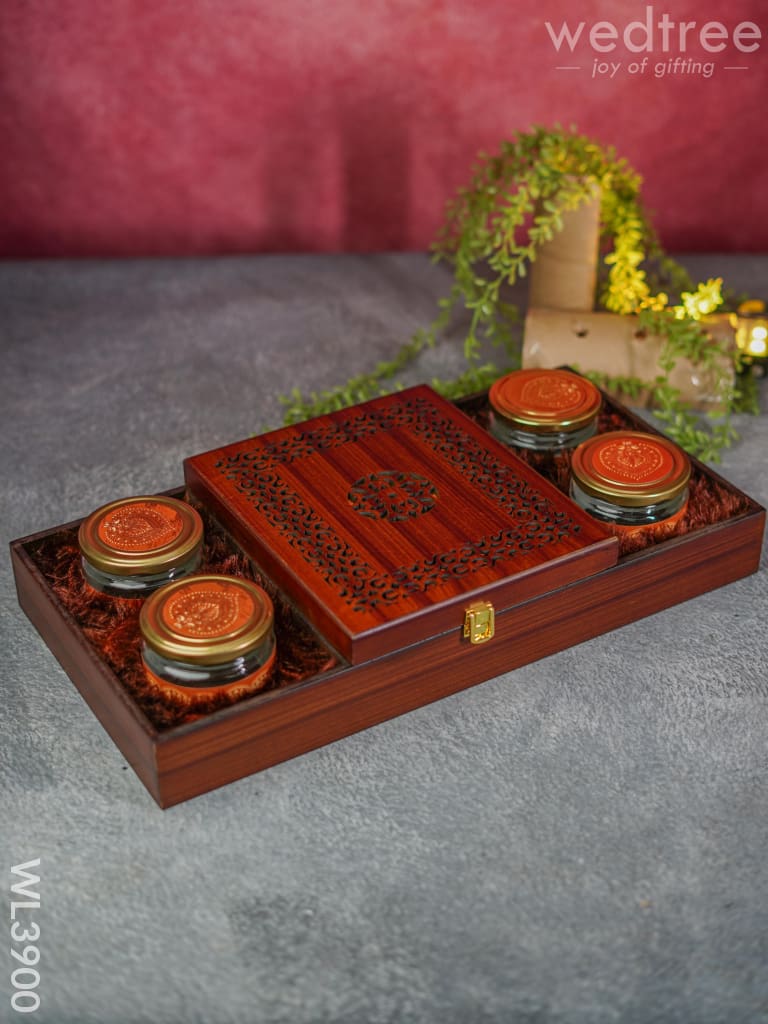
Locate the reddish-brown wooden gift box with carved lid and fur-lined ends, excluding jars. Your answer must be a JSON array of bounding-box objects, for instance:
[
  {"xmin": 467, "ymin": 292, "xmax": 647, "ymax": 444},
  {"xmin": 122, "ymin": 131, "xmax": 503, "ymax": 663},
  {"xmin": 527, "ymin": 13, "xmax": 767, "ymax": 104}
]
[{"xmin": 11, "ymin": 388, "xmax": 765, "ymax": 807}]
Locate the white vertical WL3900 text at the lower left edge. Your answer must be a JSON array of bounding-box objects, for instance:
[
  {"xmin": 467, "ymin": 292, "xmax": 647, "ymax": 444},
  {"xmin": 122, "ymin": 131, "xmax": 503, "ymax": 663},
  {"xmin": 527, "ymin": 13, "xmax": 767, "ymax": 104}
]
[{"xmin": 10, "ymin": 857, "xmax": 40, "ymax": 1014}]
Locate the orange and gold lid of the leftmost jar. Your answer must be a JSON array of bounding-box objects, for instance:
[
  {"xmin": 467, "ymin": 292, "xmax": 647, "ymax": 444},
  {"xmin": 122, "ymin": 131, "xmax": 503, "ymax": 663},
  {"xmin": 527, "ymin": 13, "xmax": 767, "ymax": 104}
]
[{"xmin": 78, "ymin": 495, "xmax": 203, "ymax": 577}]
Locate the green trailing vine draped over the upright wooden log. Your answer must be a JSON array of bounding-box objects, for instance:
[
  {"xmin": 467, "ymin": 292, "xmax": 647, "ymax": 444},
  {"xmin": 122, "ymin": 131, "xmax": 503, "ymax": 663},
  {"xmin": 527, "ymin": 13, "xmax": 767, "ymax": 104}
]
[{"xmin": 281, "ymin": 127, "xmax": 749, "ymax": 460}]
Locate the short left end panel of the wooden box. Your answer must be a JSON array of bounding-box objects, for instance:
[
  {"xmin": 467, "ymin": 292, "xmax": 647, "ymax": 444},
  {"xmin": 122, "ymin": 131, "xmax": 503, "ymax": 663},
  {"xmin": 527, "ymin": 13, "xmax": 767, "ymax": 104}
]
[{"xmin": 10, "ymin": 538, "xmax": 161, "ymax": 803}]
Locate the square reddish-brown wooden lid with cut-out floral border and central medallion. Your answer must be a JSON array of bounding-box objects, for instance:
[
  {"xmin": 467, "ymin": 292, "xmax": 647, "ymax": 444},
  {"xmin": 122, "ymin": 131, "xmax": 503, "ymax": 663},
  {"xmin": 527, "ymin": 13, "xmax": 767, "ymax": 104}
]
[{"xmin": 184, "ymin": 385, "xmax": 617, "ymax": 664}]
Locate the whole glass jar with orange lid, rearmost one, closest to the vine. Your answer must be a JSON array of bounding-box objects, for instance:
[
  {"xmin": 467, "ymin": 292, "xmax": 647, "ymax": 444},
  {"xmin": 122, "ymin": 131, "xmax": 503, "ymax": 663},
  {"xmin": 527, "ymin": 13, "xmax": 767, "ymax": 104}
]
[{"xmin": 488, "ymin": 369, "xmax": 602, "ymax": 453}]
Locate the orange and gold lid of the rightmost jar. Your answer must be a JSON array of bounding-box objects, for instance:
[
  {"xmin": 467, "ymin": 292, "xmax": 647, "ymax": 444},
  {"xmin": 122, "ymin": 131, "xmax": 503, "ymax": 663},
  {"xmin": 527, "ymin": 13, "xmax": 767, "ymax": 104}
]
[{"xmin": 570, "ymin": 430, "xmax": 690, "ymax": 508}]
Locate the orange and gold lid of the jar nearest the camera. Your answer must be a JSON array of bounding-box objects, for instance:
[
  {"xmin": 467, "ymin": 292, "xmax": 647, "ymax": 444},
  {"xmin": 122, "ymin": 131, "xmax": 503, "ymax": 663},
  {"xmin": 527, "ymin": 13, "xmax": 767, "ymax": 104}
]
[{"xmin": 139, "ymin": 574, "xmax": 274, "ymax": 665}]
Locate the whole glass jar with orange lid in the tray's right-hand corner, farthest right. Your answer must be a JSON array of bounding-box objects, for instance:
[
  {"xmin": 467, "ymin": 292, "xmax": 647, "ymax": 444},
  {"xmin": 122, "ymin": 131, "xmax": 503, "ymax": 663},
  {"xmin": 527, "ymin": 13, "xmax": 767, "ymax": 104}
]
[{"xmin": 570, "ymin": 430, "xmax": 690, "ymax": 538}]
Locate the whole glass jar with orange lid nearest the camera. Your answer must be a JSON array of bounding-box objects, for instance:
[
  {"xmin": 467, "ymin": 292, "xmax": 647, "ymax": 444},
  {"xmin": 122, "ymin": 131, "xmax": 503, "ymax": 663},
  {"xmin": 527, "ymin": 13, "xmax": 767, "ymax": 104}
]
[{"xmin": 139, "ymin": 574, "xmax": 276, "ymax": 705}]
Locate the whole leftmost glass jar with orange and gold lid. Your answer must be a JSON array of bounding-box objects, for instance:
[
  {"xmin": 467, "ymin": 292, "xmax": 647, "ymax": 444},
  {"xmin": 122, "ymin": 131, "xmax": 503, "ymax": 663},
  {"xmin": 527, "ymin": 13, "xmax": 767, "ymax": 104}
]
[{"xmin": 78, "ymin": 495, "xmax": 203, "ymax": 597}]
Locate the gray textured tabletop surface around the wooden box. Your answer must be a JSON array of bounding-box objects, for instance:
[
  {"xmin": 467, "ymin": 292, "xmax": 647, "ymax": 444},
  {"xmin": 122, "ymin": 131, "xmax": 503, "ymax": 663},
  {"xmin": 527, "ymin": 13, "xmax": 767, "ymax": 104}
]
[{"xmin": 0, "ymin": 249, "xmax": 768, "ymax": 1024}]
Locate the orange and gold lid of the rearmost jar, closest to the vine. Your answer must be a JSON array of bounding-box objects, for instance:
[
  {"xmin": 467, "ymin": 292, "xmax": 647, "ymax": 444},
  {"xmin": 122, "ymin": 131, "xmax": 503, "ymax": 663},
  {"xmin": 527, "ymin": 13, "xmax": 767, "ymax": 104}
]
[{"xmin": 488, "ymin": 369, "xmax": 602, "ymax": 433}]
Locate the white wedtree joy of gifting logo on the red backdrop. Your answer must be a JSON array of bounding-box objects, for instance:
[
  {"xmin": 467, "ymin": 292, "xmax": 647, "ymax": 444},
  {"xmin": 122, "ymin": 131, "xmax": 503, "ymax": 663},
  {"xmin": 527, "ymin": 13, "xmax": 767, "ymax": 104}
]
[{"xmin": 544, "ymin": 4, "xmax": 763, "ymax": 78}]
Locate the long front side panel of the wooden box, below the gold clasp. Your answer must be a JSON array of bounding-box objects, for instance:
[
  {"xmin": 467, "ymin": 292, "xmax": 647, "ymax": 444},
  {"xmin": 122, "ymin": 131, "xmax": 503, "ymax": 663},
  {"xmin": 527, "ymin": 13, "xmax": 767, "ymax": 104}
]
[{"xmin": 158, "ymin": 510, "xmax": 765, "ymax": 806}]
